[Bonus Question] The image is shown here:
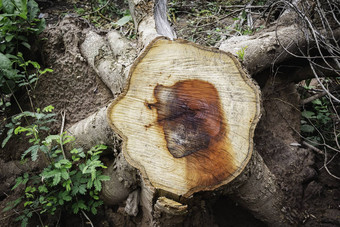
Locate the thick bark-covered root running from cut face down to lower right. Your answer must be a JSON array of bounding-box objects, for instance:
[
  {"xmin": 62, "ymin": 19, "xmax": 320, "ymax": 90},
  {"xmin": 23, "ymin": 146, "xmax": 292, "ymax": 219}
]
[{"xmin": 226, "ymin": 151, "xmax": 290, "ymax": 226}]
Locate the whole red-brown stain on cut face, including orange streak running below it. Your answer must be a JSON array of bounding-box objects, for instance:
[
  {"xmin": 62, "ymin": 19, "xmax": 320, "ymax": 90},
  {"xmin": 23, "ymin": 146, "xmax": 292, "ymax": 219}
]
[{"xmin": 154, "ymin": 80, "xmax": 235, "ymax": 186}]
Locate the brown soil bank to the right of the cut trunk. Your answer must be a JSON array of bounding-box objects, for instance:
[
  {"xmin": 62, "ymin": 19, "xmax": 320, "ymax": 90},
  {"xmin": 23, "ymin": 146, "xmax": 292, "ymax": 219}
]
[{"xmin": 254, "ymin": 78, "xmax": 340, "ymax": 226}]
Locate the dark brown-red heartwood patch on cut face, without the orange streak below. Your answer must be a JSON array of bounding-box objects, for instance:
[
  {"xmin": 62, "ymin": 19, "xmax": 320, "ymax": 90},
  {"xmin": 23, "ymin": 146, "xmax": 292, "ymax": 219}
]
[{"xmin": 154, "ymin": 80, "xmax": 225, "ymax": 158}]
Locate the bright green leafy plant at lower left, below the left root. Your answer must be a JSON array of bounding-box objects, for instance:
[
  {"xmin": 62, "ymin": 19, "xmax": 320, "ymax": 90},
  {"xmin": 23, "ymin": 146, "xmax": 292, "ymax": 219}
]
[{"xmin": 3, "ymin": 106, "xmax": 109, "ymax": 226}]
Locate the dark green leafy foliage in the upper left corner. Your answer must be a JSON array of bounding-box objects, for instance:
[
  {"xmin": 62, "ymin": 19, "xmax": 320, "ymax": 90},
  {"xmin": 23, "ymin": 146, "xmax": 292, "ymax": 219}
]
[{"xmin": 0, "ymin": 0, "xmax": 52, "ymax": 111}]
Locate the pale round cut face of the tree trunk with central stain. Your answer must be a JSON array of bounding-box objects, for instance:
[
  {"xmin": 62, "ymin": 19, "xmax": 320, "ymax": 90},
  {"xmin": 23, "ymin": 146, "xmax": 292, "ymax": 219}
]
[{"xmin": 108, "ymin": 38, "xmax": 260, "ymax": 197}]
